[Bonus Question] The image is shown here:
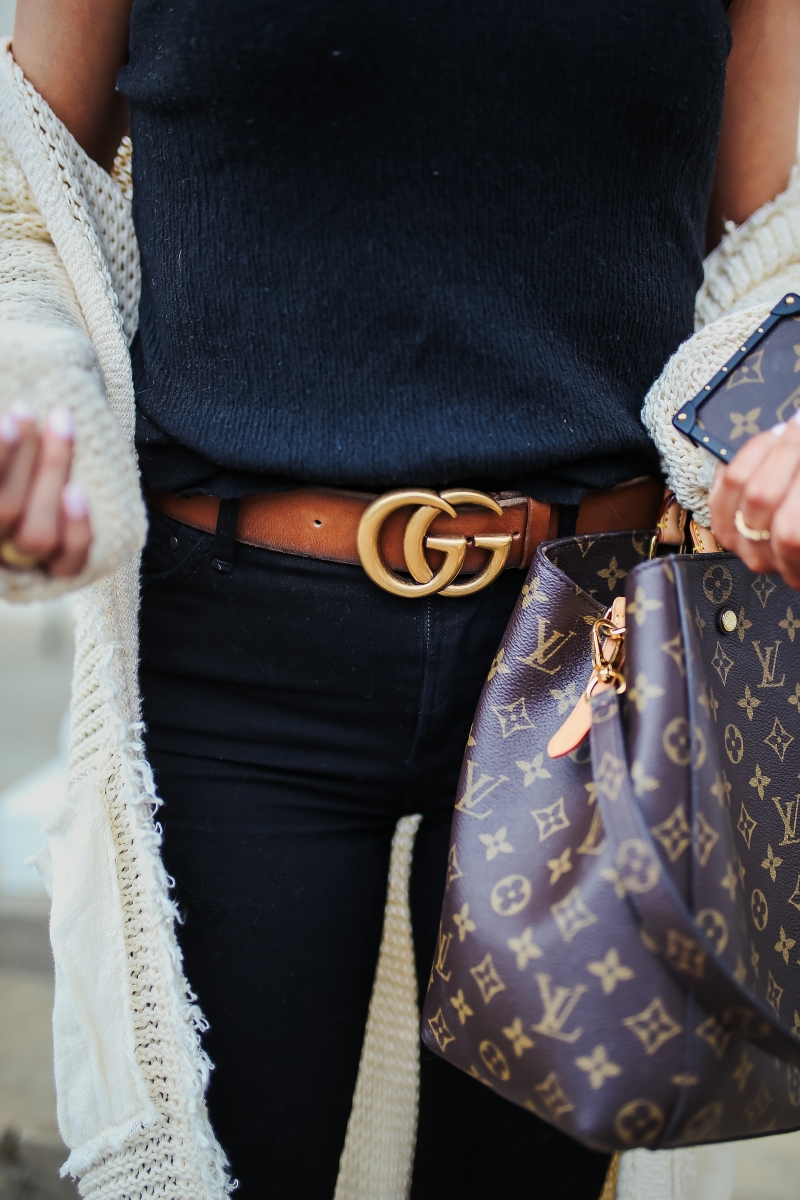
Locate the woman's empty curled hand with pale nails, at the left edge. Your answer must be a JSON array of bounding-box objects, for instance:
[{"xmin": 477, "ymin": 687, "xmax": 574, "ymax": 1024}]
[{"xmin": 0, "ymin": 406, "xmax": 91, "ymax": 578}]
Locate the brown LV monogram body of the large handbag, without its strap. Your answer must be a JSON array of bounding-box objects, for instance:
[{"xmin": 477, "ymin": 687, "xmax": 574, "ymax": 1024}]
[{"xmin": 422, "ymin": 534, "xmax": 800, "ymax": 1151}]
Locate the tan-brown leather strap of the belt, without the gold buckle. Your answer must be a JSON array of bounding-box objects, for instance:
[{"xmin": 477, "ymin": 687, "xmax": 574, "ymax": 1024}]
[{"xmin": 148, "ymin": 479, "xmax": 663, "ymax": 574}]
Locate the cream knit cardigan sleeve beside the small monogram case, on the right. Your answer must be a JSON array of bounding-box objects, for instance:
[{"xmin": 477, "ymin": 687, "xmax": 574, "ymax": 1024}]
[{"xmin": 642, "ymin": 167, "xmax": 800, "ymax": 527}]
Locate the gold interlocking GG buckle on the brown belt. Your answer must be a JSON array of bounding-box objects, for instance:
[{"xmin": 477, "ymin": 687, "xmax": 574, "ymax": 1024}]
[{"xmin": 356, "ymin": 487, "xmax": 511, "ymax": 599}]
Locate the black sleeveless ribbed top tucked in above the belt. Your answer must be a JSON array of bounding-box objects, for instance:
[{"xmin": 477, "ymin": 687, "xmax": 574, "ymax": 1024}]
[{"xmin": 119, "ymin": 0, "xmax": 730, "ymax": 503}]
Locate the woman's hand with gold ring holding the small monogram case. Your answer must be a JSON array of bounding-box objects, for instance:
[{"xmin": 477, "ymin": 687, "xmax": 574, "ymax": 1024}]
[{"xmin": 709, "ymin": 419, "xmax": 800, "ymax": 592}]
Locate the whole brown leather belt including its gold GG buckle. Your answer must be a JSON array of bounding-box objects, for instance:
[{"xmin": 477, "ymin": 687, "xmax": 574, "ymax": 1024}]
[{"xmin": 148, "ymin": 479, "xmax": 663, "ymax": 595}]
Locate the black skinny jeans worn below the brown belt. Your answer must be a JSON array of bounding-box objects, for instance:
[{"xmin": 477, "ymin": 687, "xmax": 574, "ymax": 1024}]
[{"xmin": 142, "ymin": 512, "xmax": 607, "ymax": 1200}]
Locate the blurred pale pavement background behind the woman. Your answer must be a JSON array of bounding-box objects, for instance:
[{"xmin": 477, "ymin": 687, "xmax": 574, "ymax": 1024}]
[{"xmin": 0, "ymin": 0, "xmax": 800, "ymax": 1200}]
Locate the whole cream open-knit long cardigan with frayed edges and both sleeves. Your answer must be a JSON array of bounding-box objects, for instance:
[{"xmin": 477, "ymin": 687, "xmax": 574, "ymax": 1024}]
[{"xmin": 0, "ymin": 42, "xmax": 800, "ymax": 1200}]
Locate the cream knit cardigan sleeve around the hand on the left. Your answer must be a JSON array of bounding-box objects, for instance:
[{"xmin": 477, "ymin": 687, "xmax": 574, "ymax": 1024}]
[{"xmin": 0, "ymin": 127, "xmax": 146, "ymax": 601}]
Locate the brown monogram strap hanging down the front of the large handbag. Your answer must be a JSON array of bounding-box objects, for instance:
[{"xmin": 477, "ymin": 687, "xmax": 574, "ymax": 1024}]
[{"xmin": 591, "ymin": 690, "xmax": 800, "ymax": 1067}]
